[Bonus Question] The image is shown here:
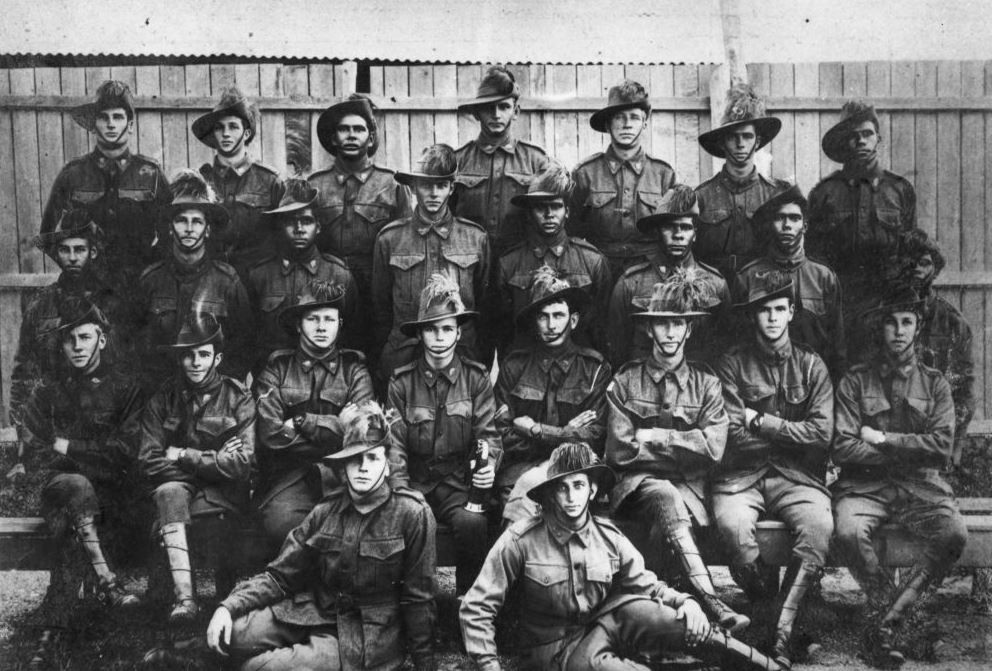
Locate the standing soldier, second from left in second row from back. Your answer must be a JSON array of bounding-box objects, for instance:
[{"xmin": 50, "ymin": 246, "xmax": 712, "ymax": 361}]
[{"xmin": 136, "ymin": 170, "xmax": 251, "ymax": 384}]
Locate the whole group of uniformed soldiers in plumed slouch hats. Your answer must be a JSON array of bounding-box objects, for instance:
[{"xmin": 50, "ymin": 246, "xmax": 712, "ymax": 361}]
[{"xmin": 10, "ymin": 66, "xmax": 974, "ymax": 671}]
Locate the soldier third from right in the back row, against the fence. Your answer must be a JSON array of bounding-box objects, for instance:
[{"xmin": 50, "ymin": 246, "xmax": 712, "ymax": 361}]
[{"xmin": 568, "ymin": 79, "xmax": 675, "ymax": 282}]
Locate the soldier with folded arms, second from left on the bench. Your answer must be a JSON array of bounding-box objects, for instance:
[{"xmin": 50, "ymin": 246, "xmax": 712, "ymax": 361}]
[{"xmin": 138, "ymin": 313, "xmax": 255, "ymax": 622}]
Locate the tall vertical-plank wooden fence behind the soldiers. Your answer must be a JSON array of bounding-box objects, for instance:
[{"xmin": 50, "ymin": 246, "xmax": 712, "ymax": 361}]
[{"xmin": 0, "ymin": 61, "xmax": 992, "ymax": 428}]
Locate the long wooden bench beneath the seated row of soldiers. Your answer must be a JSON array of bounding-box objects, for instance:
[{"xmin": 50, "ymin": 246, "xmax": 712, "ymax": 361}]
[{"xmin": 0, "ymin": 498, "xmax": 992, "ymax": 570}]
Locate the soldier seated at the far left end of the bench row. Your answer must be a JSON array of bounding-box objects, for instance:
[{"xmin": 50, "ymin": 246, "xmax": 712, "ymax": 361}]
[{"xmin": 23, "ymin": 297, "xmax": 143, "ymax": 620}]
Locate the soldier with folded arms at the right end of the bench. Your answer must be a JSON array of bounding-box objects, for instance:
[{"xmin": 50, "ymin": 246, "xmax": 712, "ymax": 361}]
[{"xmin": 832, "ymin": 288, "xmax": 968, "ymax": 668}]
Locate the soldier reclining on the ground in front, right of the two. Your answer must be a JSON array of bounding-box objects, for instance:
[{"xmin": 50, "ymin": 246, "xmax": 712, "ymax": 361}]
[{"xmin": 459, "ymin": 443, "xmax": 781, "ymax": 671}]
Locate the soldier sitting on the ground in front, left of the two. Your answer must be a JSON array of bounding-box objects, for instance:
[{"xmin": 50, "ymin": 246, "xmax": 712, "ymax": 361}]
[{"xmin": 207, "ymin": 401, "xmax": 437, "ymax": 671}]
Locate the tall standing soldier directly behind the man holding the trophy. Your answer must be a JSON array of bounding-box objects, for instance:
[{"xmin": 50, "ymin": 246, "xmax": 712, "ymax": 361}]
[{"xmin": 372, "ymin": 144, "xmax": 491, "ymax": 380}]
